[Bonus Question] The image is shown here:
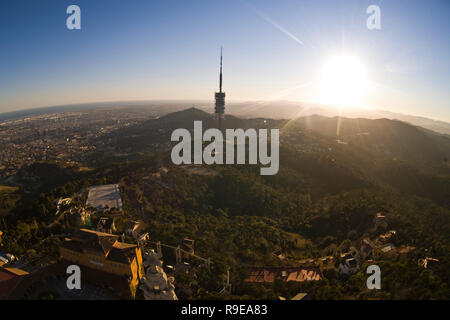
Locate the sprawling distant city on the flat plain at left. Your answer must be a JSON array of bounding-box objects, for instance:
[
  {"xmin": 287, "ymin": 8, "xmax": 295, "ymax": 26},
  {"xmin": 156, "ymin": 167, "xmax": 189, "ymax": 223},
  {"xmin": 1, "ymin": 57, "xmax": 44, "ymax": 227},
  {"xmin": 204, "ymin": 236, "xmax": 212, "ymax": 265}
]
[{"xmin": 0, "ymin": 109, "xmax": 149, "ymax": 180}]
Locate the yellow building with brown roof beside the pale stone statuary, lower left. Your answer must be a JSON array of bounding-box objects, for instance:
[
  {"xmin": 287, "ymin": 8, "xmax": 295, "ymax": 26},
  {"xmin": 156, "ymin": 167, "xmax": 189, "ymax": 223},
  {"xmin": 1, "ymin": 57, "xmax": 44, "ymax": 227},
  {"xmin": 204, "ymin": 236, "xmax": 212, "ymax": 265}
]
[{"xmin": 60, "ymin": 229, "xmax": 144, "ymax": 296}]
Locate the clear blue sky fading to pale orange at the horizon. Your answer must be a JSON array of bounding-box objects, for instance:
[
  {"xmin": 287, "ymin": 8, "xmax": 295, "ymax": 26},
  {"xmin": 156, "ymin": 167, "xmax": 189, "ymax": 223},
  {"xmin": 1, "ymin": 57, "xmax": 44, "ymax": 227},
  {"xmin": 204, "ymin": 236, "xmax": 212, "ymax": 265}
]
[{"xmin": 0, "ymin": 0, "xmax": 450, "ymax": 121}]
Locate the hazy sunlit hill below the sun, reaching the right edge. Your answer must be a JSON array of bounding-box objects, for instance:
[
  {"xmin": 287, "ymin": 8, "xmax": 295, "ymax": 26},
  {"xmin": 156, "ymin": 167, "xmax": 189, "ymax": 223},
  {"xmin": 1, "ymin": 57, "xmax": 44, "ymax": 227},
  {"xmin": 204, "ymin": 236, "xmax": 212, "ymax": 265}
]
[{"xmin": 284, "ymin": 116, "xmax": 450, "ymax": 167}]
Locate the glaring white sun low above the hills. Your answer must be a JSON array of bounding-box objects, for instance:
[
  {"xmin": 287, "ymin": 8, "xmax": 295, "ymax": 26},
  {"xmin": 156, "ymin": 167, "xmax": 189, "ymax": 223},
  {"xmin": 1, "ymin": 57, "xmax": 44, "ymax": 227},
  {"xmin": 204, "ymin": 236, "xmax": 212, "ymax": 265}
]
[{"xmin": 319, "ymin": 55, "xmax": 368, "ymax": 107}]
